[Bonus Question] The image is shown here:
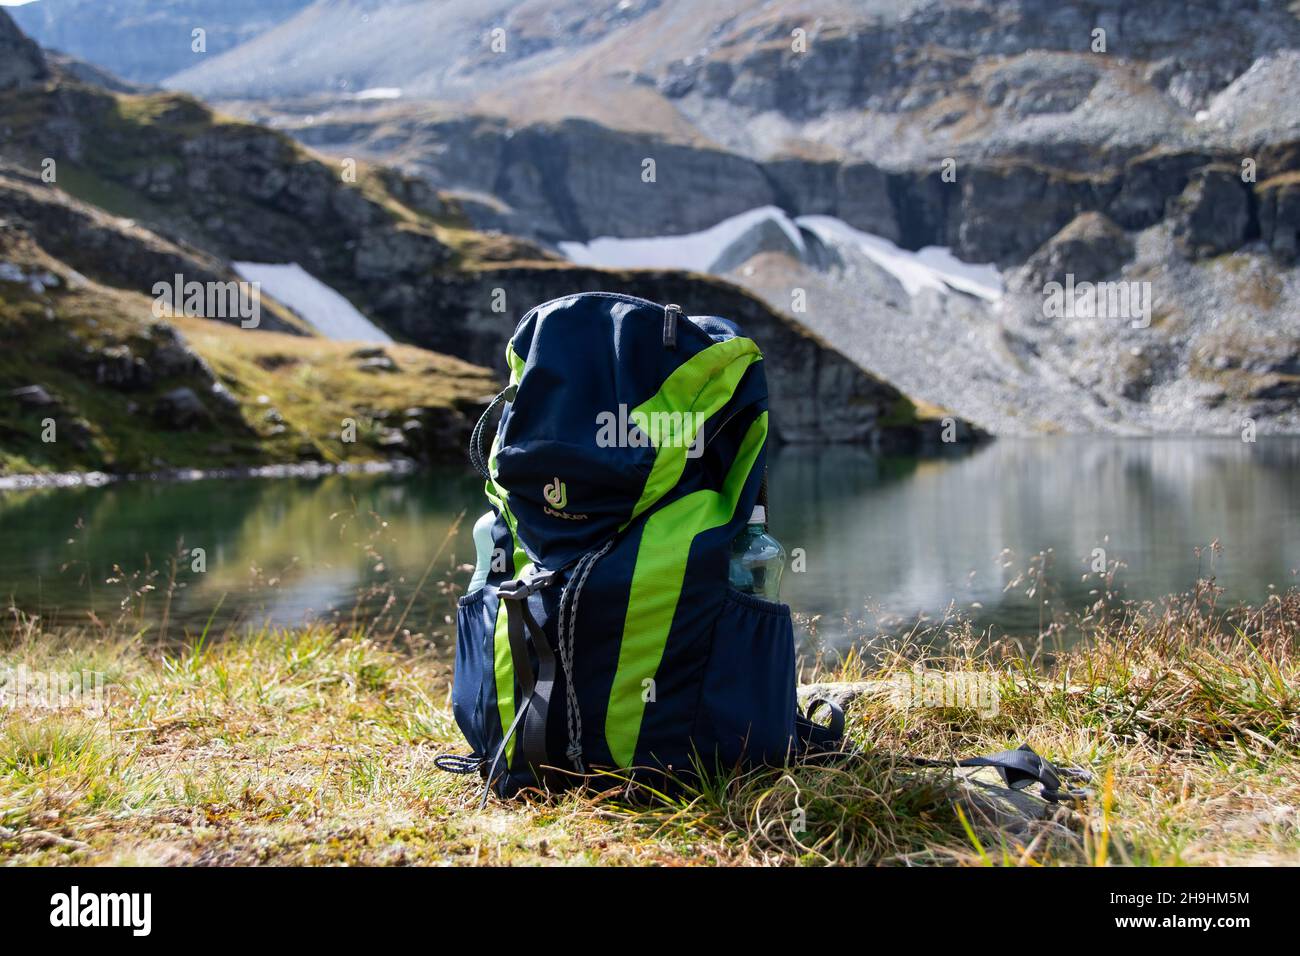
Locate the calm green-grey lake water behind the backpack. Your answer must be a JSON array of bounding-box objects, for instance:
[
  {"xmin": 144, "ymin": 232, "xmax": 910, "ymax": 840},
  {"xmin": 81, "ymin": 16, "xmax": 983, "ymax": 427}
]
[{"xmin": 0, "ymin": 438, "xmax": 1300, "ymax": 655}]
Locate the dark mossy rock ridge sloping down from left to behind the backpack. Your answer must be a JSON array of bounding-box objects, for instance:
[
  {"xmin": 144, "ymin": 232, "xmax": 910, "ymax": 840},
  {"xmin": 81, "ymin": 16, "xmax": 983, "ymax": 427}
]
[{"xmin": 0, "ymin": 12, "xmax": 946, "ymax": 470}]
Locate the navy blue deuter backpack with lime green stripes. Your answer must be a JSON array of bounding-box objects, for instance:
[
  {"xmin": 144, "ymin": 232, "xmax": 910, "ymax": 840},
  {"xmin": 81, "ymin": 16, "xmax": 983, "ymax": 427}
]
[{"xmin": 439, "ymin": 293, "xmax": 842, "ymax": 796}]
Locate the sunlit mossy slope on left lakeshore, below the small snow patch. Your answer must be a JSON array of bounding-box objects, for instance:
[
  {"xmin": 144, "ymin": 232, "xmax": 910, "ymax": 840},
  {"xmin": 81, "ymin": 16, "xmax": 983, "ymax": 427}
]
[{"xmin": 0, "ymin": 208, "xmax": 495, "ymax": 476}]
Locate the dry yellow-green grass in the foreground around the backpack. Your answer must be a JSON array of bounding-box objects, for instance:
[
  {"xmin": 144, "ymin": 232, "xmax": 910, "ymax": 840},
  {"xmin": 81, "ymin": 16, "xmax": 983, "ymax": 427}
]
[{"xmin": 0, "ymin": 588, "xmax": 1300, "ymax": 865}]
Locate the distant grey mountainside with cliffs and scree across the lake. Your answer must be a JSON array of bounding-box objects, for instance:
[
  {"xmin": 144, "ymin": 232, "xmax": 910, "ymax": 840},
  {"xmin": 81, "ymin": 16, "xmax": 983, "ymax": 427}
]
[{"xmin": 157, "ymin": 0, "xmax": 1300, "ymax": 433}]
